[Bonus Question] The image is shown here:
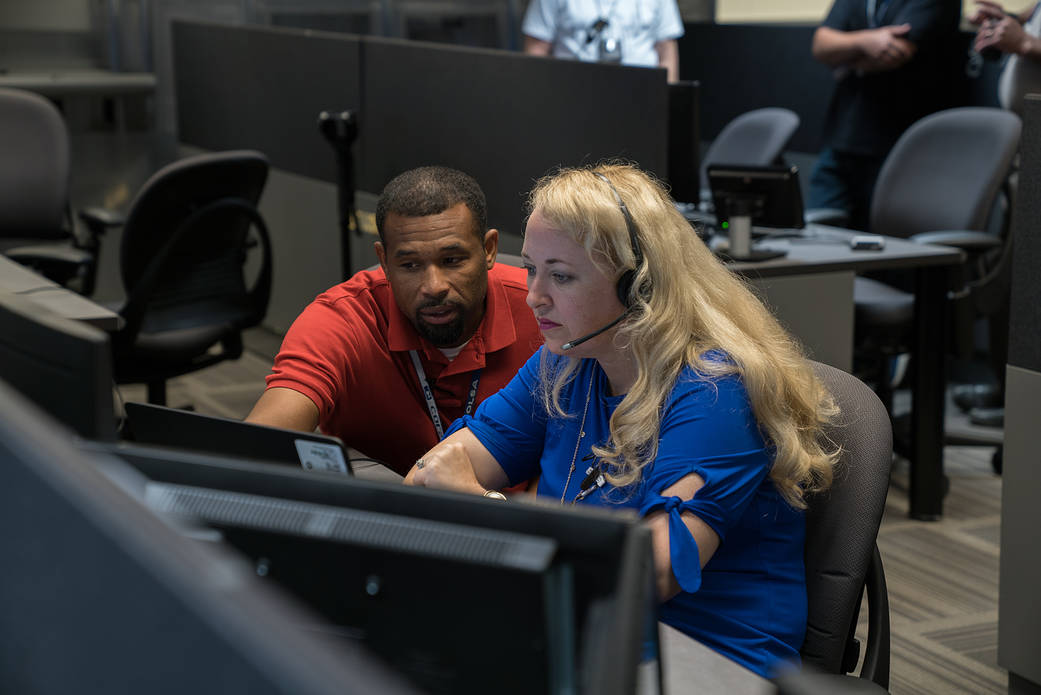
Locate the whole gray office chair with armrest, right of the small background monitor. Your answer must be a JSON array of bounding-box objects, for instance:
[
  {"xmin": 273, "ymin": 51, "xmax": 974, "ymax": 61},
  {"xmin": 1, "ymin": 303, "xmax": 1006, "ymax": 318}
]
[{"xmin": 854, "ymin": 107, "xmax": 1021, "ymax": 426}]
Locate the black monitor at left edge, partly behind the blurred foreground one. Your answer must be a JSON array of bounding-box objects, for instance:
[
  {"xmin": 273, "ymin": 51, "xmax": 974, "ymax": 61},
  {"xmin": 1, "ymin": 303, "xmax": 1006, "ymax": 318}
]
[{"xmin": 0, "ymin": 292, "xmax": 116, "ymax": 440}]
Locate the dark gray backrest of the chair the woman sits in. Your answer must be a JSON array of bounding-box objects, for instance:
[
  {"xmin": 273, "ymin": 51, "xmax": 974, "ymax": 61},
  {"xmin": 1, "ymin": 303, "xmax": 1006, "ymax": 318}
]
[{"xmin": 801, "ymin": 363, "xmax": 893, "ymax": 673}]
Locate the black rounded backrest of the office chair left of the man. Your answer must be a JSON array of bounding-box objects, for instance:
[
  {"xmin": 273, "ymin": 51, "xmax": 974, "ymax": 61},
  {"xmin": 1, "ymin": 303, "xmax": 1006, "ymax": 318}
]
[{"xmin": 120, "ymin": 150, "xmax": 271, "ymax": 333}]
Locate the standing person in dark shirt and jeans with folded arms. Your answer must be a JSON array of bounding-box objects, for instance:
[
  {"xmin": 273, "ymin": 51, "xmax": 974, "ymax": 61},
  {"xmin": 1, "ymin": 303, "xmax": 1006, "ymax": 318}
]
[{"xmin": 808, "ymin": 0, "xmax": 960, "ymax": 234}]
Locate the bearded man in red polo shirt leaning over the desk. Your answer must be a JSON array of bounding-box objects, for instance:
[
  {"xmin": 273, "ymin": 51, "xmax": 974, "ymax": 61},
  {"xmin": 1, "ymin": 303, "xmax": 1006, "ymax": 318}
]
[{"xmin": 246, "ymin": 166, "xmax": 542, "ymax": 474}]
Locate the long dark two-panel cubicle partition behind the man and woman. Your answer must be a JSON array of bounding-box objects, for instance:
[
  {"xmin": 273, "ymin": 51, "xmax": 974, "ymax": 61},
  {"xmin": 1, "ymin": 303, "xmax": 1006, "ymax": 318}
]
[{"xmin": 173, "ymin": 21, "xmax": 667, "ymax": 235}]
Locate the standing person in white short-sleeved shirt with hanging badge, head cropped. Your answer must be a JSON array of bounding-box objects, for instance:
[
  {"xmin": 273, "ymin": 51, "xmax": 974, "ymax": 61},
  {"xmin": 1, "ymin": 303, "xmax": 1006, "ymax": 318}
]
[{"xmin": 522, "ymin": 0, "xmax": 683, "ymax": 82}]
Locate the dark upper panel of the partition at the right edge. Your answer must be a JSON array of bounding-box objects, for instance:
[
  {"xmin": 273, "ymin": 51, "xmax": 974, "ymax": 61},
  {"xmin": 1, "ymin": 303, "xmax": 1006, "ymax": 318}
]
[{"xmin": 1009, "ymin": 97, "xmax": 1041, "ymax": 371}]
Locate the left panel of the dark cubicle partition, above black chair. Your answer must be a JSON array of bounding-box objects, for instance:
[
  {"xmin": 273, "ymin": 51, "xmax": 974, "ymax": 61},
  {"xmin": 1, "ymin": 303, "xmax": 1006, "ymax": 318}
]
[{"xmin": 172, "ymin": 21, "xmax": 361, "ymax": 181}]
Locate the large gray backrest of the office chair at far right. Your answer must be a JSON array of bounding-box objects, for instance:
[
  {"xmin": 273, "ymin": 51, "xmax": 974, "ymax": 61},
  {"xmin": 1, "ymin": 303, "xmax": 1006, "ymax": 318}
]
[{"xmin": 869, "ymin": 107, "xmax": 1022, "ymax": 237}]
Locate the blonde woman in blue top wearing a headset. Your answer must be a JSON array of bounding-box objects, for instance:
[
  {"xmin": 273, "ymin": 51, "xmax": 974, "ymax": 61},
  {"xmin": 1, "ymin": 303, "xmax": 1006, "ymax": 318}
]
[{"xmin": 406, "ymin": 165, "xmax": 836, "ymax": 676}]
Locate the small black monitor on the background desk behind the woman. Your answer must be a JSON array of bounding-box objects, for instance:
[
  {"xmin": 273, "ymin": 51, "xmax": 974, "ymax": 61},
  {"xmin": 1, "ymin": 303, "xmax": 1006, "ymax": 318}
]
[{"xmin": 708, "ymin": 164, "xmax": 805, "ymax": 229}]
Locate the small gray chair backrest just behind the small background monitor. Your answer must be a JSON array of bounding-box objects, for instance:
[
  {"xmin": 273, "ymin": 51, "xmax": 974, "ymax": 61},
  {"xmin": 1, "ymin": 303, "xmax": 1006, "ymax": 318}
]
[{"xmin": 701, "ymin": 107, "xmax": 799, "ymax": 190}]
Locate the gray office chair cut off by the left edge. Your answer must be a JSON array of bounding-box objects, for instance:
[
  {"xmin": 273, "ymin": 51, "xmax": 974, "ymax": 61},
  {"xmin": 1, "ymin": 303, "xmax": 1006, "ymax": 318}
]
[{"xmin": 0, "ymin": 88, "xmax": 98, "ymax": 294}]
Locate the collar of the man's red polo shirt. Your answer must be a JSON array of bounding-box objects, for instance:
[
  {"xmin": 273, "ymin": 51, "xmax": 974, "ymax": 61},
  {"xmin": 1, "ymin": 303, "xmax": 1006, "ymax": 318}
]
[{"xmin": 387, "ymin": 266, "xmax": 516, "ymax": 377}]
